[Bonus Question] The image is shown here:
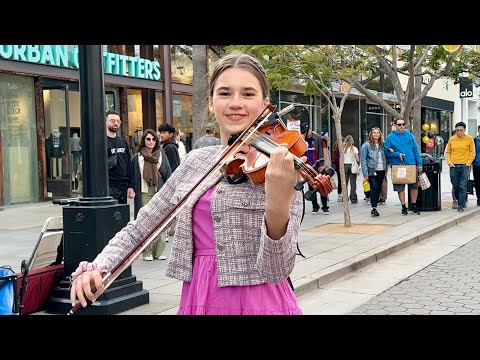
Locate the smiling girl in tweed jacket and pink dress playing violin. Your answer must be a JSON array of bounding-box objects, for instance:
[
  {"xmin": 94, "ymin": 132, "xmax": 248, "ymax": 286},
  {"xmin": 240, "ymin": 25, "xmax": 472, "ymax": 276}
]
[{"xmin": 71, "ymin": 53, "xmax": 303, "ymax": 315}]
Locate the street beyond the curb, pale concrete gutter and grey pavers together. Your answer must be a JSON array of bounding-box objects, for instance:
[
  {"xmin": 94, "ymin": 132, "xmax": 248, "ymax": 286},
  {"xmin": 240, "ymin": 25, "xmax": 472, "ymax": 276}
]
[{"xmin": 298, "ymin": 216, "xmax": 480, "ymax": 315}]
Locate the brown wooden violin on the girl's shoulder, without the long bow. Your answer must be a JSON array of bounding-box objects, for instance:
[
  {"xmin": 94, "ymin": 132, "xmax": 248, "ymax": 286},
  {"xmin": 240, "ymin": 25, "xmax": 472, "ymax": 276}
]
[{"xmin": 223, "ymin": 105, "xmax": 332, "ymax": 197}]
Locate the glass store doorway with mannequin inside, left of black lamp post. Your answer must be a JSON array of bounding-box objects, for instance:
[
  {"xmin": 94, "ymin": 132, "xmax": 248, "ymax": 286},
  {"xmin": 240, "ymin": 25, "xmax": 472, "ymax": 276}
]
[{"xmin": 43, "ymin": 85, "xmax": 73, "ymax": 199}]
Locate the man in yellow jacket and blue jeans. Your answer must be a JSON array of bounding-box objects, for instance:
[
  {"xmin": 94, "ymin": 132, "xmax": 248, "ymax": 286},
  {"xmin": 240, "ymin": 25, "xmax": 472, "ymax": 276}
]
[{"xmin": 445, "ymin": 121, "xmax": 475, "ymax": 212}]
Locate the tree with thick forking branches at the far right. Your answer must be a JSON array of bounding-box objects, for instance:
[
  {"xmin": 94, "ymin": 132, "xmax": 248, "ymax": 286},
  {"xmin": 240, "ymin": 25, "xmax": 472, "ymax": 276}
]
[{"xmin": 344, "ymin": 45, "xmax": 480, "ymax": 144}]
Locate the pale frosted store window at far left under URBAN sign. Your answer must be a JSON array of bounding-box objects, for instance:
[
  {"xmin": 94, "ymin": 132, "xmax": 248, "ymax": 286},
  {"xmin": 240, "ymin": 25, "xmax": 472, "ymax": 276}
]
[{"xmin": 0, "ymin": 74, "xmax": 39, "ymax": 205}]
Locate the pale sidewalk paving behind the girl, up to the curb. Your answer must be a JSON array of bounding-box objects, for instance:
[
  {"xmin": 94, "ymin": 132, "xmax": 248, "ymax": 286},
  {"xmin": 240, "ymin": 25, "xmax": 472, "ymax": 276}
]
[{"xmin": 0, "ymin": 159, "xmax": 480, "ymax": 315}]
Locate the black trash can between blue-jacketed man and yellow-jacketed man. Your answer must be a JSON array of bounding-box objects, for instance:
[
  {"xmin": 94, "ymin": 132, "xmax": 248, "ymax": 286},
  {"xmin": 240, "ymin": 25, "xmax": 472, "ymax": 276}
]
[{"xmin": 408, "ymin": 153, "xmax": 442, "ymax": 211}]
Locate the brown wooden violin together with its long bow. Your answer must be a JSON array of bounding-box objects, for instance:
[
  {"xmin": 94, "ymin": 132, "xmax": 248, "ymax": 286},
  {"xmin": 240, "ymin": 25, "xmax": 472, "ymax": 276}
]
[{"xmin": 67, "ymin": 105, "xmax": 332, "ymax": 315}]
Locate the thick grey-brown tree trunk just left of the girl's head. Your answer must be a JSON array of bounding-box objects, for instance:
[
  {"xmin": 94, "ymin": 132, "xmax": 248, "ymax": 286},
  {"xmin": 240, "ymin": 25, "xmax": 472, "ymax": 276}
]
[{"xmin": 192, "ymin": 45, "xmax": 208, "ymax": 146}]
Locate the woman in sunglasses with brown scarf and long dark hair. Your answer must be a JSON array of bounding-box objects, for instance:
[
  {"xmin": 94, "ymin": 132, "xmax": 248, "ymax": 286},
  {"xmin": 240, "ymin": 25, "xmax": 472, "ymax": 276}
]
[{"xmin": 132, "ymin": 129, "xmax": 172, "ymax": 261}]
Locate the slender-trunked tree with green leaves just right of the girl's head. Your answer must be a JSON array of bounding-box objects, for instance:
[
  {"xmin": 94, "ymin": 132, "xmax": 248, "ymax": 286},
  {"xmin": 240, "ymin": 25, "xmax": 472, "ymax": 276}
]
[{"xmin": 227, "ymin": 45, "xmax": 370, "ymax": 227}]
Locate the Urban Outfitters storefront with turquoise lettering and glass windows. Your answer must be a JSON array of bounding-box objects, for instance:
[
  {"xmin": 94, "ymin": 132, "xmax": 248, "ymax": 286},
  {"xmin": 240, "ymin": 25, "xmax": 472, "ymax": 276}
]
[{"xmin": 0, "ymin": 45, "xmax": 172, "ymax": 205}]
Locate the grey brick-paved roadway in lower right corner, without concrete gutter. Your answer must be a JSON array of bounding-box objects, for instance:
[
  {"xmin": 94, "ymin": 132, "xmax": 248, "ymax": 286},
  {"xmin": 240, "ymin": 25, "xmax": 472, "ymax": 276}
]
[{"xmin": 348, "ymin": 228, "xmax": 480, "ymax": 315}]
